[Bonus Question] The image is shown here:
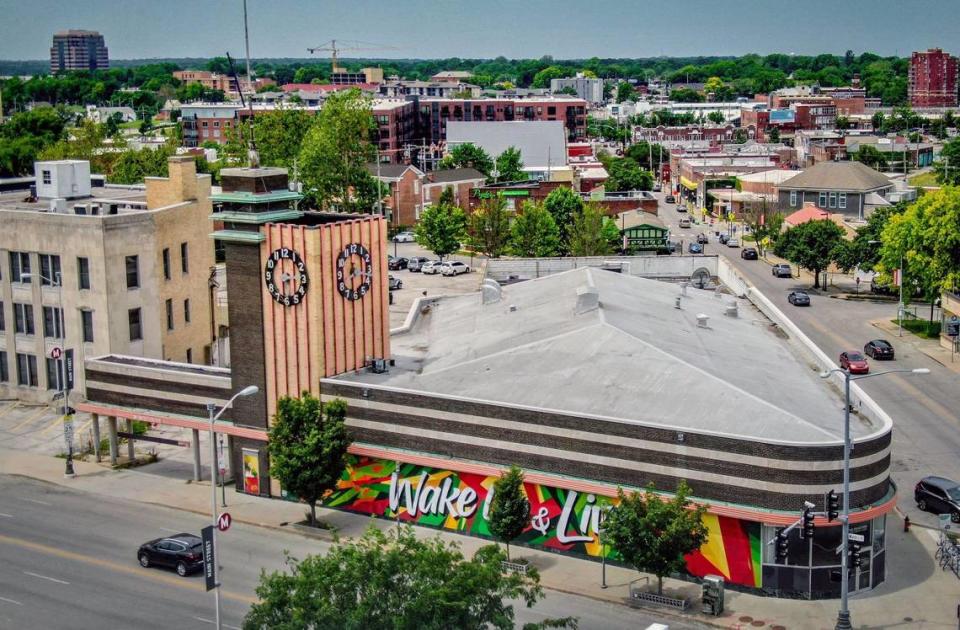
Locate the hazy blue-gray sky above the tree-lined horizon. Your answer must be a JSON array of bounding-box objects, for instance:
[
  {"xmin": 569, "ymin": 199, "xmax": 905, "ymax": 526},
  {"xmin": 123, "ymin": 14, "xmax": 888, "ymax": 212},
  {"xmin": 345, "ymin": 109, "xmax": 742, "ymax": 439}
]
[{"xmin": 0, "ymin": 0, "xmax": 960, "ymax": 59}]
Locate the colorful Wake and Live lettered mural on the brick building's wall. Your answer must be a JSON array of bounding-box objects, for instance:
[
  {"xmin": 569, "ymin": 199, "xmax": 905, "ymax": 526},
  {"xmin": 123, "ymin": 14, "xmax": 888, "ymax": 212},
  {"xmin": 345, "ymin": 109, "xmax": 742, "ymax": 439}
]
[{"xmin": 324, "ymin": 457, "xmax": 761, "ymax": 588}]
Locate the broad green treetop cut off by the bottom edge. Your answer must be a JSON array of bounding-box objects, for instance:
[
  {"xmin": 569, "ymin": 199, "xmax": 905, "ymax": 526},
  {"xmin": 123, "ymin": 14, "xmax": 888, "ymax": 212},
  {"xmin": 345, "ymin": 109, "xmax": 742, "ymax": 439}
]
[{"xmin": 243, "ymin": 526, "xmax": 576, "ymax": 630}]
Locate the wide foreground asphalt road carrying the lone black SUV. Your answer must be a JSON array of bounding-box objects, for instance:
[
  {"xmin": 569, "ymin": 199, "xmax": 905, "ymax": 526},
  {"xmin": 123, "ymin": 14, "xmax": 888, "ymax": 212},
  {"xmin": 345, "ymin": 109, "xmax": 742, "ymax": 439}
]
[{"xmin": 0, "ymin": 475, "xmax": 698, "ymax": 630}]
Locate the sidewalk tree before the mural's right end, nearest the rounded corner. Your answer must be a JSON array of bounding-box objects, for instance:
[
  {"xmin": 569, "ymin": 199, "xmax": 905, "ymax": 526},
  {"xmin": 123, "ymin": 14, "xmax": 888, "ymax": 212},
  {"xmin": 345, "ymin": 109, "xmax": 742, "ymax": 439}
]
[{"xmin": 603, "ymin": 480, "xmax": 708, "ymax": 594}]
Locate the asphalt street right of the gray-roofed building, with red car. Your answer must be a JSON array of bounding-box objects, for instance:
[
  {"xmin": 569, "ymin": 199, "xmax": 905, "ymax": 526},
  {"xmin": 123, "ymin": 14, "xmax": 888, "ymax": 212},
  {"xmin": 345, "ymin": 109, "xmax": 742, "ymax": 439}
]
[{"xmin": 658, "ymin": 194, "xmax": 960, "ymax": 525}]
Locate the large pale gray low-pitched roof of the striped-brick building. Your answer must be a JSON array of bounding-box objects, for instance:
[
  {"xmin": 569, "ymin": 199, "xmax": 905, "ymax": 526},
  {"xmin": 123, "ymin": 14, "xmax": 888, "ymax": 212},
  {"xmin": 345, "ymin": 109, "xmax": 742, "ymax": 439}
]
[{"xmin": 338, "ymin": 268, "xmax": 884, "ymax": 444}]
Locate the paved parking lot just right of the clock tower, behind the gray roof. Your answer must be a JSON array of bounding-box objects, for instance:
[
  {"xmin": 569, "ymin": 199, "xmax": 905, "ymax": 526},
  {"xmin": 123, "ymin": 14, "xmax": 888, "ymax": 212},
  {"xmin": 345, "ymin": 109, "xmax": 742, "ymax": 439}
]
[{"xmin": 390, "ymin": 243, "xmax": 483, "ymax": 328}]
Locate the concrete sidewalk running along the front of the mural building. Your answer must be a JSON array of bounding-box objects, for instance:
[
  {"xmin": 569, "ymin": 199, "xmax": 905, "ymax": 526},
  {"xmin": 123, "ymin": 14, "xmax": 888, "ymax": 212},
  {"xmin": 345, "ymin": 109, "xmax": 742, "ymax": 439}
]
[{"xmin": 0, "ymin": 448, "xmax": 960, "ymax": 629}]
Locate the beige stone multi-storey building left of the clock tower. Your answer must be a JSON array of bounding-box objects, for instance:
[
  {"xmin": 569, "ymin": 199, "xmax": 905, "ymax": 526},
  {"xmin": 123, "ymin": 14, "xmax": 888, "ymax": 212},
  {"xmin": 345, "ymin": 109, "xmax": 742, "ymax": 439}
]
[{"xmin": 0, "ymin": 157, "xmax": 214, "ymax": 402}]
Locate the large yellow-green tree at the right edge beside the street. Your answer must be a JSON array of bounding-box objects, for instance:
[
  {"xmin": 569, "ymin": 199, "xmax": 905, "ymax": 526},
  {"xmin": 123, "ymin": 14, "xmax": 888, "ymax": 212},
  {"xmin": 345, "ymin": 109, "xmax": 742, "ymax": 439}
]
[{"xmin": 877, "ymin": 186, "xmax": 960, "ymax": 299}]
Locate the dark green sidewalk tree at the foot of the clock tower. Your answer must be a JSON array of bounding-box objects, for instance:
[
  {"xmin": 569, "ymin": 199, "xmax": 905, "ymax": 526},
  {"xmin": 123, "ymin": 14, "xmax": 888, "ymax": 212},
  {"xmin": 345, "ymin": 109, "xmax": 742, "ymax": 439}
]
[{"xmin": 267, "ymin": 392, "xmax": 350, "ymax": 525}]
